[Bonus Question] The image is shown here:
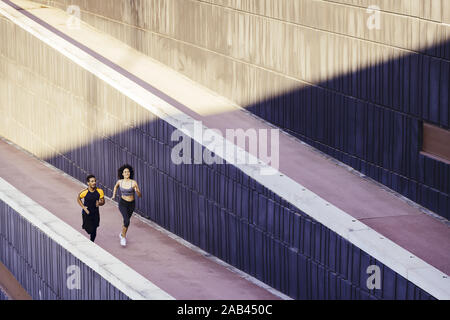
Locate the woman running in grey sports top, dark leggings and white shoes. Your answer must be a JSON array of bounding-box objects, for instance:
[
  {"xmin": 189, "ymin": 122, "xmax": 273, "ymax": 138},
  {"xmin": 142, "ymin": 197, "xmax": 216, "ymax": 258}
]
[{"xmin": 112, "ymin": 164, "xmax": 142, "ymax": 247}]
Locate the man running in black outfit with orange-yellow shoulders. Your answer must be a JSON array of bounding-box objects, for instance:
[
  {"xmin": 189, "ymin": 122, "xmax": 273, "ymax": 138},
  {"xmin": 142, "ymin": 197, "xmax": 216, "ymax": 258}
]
[{"xmin": 77, "ymin": 175, "xmax": 105, "ymax": 242}]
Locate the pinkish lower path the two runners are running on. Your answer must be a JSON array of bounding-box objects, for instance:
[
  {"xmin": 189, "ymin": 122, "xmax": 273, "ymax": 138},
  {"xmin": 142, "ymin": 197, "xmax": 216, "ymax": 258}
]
[{"xmin": 0, "ymin": 139, "xmax": 283, "ymax": 300}]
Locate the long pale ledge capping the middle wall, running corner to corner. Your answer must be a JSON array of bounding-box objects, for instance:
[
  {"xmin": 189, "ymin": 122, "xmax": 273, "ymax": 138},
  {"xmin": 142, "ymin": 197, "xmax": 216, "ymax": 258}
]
[{"xmin": 0, "ymin": 2, "xmax": 450, "ymax": 300}]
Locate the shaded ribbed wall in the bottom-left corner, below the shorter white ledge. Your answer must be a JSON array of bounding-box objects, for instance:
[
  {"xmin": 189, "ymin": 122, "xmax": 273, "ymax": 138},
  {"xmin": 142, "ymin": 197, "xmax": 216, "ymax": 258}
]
[{"xmin": 0, "ymin": 200, "xmax": 128, "ymax": 300}]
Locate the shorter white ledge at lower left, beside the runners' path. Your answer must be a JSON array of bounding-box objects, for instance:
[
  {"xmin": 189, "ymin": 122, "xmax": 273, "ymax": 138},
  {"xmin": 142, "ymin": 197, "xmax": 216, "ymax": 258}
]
[{"xmin": 0, "ymin": 178, "xmax": 174, "ymax": 300}]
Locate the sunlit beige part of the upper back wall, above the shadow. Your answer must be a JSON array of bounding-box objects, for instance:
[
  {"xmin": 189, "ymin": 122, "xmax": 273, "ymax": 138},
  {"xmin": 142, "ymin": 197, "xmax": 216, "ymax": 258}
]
[{"xmin": 33, "ymin": 0, "xmax": 450, "ymax": 106}]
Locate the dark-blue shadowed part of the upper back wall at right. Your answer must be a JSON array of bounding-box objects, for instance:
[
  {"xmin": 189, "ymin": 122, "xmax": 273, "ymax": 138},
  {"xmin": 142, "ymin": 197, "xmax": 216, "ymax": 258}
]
[{"xmin": 247, "ymin": 42, "xmax": 450, "ymax": 219}]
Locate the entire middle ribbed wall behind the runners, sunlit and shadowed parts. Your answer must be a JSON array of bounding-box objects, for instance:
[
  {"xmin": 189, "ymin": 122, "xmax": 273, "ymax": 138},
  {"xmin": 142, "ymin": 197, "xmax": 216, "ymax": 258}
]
[{"xmin": 0, "ymin": 10, "xmax": 440, "ymax": 299}]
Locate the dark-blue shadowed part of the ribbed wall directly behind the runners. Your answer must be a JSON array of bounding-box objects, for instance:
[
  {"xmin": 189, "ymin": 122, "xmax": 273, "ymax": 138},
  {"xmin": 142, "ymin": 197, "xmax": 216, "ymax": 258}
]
[{"xmin": 46, "ymin": 114, "xmax": 432, "ymax": 299}]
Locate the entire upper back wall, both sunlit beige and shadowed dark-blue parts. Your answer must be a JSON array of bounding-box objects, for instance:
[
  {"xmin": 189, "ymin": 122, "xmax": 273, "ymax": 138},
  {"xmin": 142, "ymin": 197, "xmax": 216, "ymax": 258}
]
[{"xmin": 29, "ymin": 0, "xmax": 450, "ymax": 218}]
